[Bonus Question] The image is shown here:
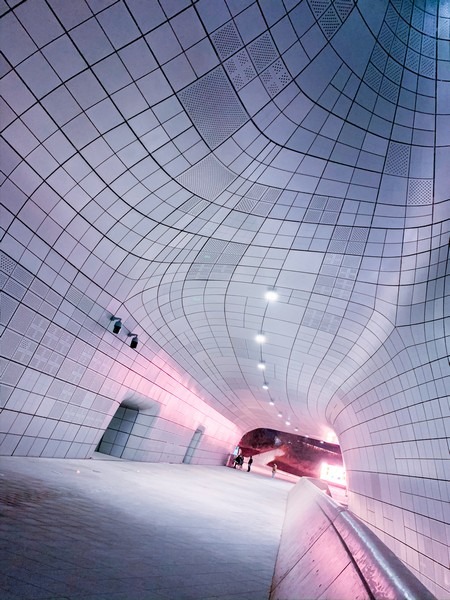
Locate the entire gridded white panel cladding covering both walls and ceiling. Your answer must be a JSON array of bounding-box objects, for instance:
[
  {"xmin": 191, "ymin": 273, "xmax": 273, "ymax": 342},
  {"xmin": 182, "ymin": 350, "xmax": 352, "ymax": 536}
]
[{"xmin": 0, "ymin": 0, "xmax": 450, "ymax": 594}]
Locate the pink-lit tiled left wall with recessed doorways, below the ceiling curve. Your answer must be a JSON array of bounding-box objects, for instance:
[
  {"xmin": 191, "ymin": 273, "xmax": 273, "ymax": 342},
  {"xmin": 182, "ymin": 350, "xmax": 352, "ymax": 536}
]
[{"xmin": 0, "ymin": 253, "xmax": 240, "ymax": 464}]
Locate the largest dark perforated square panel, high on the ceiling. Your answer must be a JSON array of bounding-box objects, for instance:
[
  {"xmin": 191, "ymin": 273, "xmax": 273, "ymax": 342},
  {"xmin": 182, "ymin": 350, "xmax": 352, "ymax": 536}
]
[{"xmin": 178, "ymin": 67, "xmax": 248, "ymax": 148}]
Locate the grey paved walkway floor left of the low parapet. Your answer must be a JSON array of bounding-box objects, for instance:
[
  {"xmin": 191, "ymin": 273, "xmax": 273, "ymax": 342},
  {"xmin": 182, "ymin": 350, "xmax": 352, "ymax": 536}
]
[{"xmin": 0, "ymin": 455, "xmax": 293, "ymax": 600}]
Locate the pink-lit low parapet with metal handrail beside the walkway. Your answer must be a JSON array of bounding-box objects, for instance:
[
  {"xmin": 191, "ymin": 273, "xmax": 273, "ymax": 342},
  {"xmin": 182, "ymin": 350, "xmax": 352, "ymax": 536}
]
[{"xmin": 270, "ymin": 479, "xmax": 436, "ymax": 600}]
